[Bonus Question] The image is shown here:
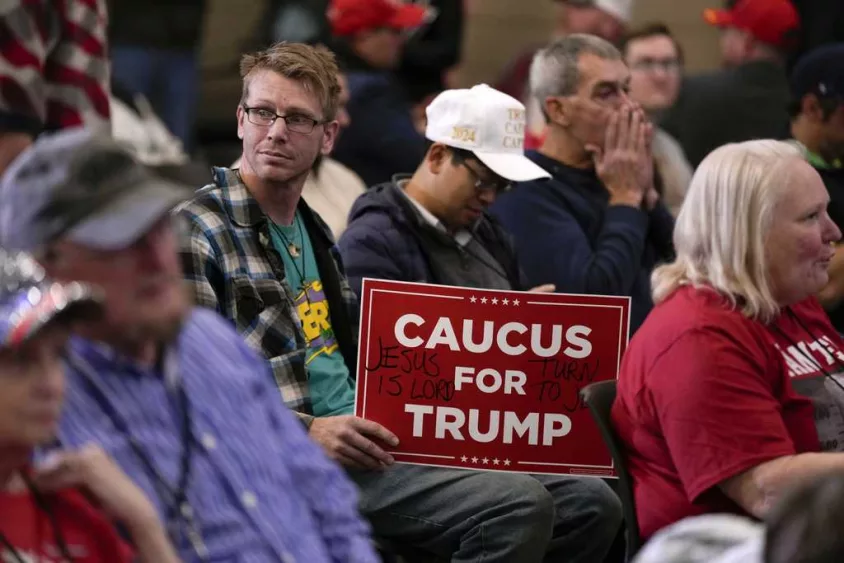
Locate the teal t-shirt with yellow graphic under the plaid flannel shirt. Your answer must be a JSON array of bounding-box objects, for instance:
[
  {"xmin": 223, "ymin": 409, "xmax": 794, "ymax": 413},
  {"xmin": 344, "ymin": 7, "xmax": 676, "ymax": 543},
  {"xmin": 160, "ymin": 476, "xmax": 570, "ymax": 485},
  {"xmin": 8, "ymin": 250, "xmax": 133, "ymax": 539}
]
[{"xmin": 270, "ymin": 211, "xmax": 355, "ymax": 416}]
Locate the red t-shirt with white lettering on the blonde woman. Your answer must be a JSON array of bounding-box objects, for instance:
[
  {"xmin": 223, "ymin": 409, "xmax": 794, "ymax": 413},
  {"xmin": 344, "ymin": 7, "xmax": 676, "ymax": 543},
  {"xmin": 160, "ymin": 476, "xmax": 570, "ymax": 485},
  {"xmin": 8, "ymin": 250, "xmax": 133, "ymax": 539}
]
[{"xmin": 612, "ymin": 287, "xmax": 844, "ymax": 538}]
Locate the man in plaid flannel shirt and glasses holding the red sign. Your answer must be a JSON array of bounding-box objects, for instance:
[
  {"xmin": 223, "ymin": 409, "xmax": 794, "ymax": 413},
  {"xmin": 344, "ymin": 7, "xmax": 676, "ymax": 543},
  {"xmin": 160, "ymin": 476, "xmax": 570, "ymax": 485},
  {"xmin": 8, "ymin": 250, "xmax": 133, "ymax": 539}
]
[{"xmin": 180, "ymin": 40, "xmax": 602, "ymax": 563}]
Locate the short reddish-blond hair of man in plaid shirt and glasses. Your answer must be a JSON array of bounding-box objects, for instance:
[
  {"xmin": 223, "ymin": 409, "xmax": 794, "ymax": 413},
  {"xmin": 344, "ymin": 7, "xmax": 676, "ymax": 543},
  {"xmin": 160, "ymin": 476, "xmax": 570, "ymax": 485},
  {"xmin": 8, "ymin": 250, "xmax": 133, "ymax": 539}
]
[{"xmin": 240, "ymin": 41, "xmax": 340, "ymax": 121}]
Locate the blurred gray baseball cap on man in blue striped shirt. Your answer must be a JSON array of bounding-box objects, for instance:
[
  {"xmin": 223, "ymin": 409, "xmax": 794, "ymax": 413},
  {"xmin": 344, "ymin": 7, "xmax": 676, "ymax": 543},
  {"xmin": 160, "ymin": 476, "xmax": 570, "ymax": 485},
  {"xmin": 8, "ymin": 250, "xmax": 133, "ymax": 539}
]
[{"xmin": 0, "ymin": 128, "xmax": 193, "ymax": 252}]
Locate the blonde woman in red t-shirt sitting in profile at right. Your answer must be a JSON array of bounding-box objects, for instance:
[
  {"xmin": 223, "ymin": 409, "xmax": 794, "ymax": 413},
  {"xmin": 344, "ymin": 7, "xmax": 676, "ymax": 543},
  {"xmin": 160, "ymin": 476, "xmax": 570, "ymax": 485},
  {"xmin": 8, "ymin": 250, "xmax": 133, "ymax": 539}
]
[{"xmin": 612, "ymin": 141, "xmax": 844, "ymax": 538}]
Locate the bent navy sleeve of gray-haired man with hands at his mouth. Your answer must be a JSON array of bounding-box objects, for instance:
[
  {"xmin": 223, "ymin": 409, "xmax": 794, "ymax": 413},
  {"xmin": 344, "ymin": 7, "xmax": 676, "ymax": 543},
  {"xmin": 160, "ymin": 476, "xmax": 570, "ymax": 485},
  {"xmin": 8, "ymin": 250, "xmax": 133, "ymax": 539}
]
[{"xmin": 493, "ymin": 184, "xmax": 648, "ymax": 295}]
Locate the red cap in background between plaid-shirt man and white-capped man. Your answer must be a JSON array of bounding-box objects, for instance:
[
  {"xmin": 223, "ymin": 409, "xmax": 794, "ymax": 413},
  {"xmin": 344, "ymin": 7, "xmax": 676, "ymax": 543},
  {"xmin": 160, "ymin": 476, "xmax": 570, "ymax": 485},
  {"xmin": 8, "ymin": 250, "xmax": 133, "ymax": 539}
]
[{"xmin": 328, "ymin": 0, "xmax": 428, "ymax": 36}]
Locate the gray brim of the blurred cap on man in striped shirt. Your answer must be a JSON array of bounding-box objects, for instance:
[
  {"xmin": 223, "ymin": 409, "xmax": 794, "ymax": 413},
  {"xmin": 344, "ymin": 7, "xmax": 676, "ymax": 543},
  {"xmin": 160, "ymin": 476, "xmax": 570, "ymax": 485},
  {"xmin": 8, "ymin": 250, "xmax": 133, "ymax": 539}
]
[{"xmin": 66, "ymin": 180, "xmax": 185, "ymax": 250}]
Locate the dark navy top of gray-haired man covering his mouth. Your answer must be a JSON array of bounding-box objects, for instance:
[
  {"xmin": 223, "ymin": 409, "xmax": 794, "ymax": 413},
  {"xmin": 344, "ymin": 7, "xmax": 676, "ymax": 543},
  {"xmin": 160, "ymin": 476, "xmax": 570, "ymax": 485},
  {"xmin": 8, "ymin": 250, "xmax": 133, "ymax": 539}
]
[{"xmin": 492, "ymin": 151, "xmax": 674, "ymax": 334}]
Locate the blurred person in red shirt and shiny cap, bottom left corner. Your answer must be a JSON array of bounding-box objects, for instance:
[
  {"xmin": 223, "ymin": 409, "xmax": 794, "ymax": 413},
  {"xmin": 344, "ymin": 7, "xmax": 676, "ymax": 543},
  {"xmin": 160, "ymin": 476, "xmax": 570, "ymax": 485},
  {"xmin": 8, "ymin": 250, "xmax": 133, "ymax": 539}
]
[{"xmin": 0, "ymin": 251, "xmax": 179, "ymax": 563}]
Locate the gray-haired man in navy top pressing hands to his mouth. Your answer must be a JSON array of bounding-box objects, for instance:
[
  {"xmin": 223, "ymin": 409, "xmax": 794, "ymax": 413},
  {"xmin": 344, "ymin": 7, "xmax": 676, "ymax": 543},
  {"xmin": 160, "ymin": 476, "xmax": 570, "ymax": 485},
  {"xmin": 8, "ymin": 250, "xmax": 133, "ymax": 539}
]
[{"xmin": 492, "ymin": 34, "xmax": 674, "ymax": 332}]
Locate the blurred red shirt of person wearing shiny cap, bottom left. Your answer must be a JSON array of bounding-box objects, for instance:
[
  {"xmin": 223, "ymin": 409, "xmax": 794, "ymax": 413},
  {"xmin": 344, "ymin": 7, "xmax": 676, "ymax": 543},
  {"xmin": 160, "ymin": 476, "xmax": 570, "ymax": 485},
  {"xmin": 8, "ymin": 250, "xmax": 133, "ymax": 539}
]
[{"xmin": 0, "ymin": 489, "xmax": 133, "ymax": 563}]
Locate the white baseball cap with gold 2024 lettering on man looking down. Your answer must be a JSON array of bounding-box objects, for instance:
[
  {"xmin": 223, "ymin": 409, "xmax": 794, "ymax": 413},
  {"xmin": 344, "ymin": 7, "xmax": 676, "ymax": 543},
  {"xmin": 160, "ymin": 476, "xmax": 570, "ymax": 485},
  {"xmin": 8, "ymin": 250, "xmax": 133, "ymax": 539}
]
[{"xmin": 425, "ymin": 84, "xmax": 551, "ymax": 182}]
